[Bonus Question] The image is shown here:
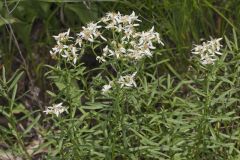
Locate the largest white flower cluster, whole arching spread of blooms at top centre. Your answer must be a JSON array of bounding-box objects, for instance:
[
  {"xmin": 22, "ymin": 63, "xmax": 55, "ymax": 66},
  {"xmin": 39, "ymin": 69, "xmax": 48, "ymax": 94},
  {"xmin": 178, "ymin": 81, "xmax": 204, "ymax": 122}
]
[{"xmin": 50, "ymin": 12, "xmax": 164, "ymax": 64}]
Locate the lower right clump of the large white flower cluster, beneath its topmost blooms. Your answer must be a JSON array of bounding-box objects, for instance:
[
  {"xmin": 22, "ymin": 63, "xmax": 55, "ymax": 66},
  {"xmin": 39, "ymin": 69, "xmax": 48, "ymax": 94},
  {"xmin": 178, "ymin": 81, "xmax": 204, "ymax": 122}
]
[{"xmin": 101, "ymin": 27, "xmax": 164, "ymax": 62}]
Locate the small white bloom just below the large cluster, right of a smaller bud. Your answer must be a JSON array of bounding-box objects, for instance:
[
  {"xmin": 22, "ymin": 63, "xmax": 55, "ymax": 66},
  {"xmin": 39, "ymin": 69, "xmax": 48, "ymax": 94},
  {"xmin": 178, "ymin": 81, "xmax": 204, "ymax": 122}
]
[{"xmin": 117, "ymin": 72, "xmax": 137, "ymax": 88}]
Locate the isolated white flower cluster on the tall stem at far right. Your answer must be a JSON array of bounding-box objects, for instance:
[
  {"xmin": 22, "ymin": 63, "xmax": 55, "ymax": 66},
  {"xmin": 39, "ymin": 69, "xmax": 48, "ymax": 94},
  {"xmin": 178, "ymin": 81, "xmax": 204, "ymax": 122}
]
[{"xmin": 192, "ymin": 38, "xmax": 222, "ymax": 65}]
